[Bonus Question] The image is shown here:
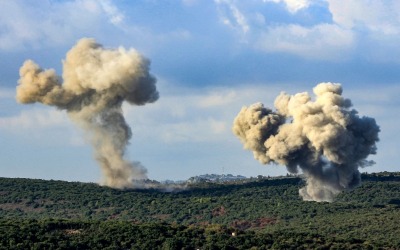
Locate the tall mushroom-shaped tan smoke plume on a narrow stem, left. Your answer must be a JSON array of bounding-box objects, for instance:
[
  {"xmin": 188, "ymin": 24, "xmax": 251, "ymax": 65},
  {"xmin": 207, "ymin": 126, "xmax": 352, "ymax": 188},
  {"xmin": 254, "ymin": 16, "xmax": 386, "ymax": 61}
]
[{"xmin": 16, "ymin": 38, "xmax": 159, "ymax": 188}]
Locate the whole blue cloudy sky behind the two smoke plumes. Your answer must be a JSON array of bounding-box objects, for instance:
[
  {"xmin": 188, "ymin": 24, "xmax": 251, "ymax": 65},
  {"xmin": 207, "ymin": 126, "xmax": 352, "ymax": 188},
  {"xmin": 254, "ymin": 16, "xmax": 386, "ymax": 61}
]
[{"xmin": 0, "ymin": 0, "xmax": 400, "ymax": 182}]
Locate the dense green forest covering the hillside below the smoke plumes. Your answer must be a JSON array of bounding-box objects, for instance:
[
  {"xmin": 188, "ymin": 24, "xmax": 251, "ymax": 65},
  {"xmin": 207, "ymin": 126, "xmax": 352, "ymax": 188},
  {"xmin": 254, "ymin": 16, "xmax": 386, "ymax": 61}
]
[{"xmin": 0, "ymin": 172, "xmax": 400, "ymax": 249}]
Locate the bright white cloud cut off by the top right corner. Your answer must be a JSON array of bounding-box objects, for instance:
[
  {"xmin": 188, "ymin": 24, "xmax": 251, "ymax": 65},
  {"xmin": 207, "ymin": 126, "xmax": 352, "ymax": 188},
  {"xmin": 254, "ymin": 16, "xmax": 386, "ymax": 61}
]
[{"xmin": 327, "ymin": 0, "xmax": 400, "ymax": 62}]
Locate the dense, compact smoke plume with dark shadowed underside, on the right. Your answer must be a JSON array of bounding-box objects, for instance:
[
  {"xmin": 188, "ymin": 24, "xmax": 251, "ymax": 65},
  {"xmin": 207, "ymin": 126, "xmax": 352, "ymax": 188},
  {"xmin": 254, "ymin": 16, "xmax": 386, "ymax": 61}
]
[{"xmin": 232, "ymin": 83, "xmax": 380, "ymax": 201}]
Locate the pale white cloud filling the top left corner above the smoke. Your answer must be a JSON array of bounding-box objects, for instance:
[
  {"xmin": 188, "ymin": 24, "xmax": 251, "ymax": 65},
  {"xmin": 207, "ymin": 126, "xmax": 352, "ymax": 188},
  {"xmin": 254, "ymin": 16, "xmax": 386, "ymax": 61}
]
[{"xmin": 0, "ymin": 0, "xmax": 124, "ymax": 51}]
